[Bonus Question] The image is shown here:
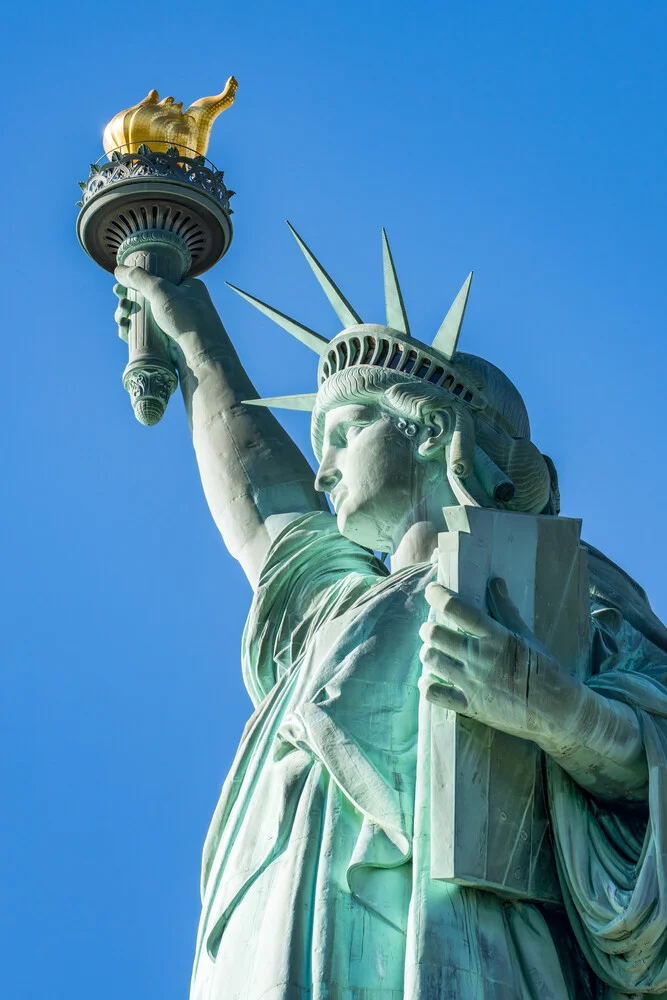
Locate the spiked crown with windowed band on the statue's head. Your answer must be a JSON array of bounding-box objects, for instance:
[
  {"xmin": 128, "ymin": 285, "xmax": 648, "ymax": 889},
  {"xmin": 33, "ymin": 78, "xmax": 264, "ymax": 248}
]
[{"xmin": 227, "ymin": 222, "xmax": 487, "ymax": 410}]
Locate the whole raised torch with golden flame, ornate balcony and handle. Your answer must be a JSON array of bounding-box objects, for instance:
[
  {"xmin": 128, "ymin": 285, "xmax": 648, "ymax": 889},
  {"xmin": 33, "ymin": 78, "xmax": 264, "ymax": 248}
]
[{"xmin": 77, "ymin": 83, "xmax": 238, "ymax": 426}]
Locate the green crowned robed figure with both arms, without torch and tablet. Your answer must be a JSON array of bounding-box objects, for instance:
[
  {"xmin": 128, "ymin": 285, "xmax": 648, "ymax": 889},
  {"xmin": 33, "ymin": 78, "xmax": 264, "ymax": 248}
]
[{"xmin": 116, "ymin": 227, "xmax": 667, "ymax": 1000}]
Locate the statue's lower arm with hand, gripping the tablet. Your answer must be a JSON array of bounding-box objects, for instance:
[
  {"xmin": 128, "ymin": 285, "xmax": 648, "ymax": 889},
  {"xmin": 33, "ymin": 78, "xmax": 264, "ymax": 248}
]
[{"xmin": 420, "ymin": 580, "xmax": 648, "ymax": 802}]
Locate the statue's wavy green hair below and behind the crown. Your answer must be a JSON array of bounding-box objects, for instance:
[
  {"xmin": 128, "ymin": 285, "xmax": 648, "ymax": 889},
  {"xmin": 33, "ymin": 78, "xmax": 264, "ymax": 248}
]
[{"xmin": 311, "ymin": 353, "xmax": 559, "ymax": 514}]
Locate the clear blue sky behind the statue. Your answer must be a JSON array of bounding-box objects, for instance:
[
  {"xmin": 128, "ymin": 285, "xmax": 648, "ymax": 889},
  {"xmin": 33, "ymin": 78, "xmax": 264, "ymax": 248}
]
[{"xmin": 0, "ymin": 0, "xmax": 667, "ymax": 1000}]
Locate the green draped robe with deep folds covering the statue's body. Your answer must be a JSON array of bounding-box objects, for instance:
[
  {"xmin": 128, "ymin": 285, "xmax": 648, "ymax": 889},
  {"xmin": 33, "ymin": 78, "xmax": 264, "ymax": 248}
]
[{"xmin": 191, "ymin": 512, "xmax": 667, "ymax": 1000}]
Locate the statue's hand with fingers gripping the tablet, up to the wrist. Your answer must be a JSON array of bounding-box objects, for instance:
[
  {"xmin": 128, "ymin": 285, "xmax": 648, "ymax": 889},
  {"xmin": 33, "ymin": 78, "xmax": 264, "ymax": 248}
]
[{"xmin": 419, "ymin": 579, "xmax": 578, "ymax": 743}]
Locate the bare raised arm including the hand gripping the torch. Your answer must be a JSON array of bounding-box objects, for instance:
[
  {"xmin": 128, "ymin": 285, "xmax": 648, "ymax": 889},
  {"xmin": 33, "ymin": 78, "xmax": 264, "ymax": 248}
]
[{"xmin": 115, "ymin": 267, "xmax": 324, "ymax": 586}]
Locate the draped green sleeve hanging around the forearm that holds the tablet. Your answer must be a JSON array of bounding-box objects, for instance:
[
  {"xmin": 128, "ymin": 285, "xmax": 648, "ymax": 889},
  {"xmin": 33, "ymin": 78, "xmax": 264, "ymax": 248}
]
[{"xmin": 547, "ymin": 622, "xmax": 667, "ymax": 997}]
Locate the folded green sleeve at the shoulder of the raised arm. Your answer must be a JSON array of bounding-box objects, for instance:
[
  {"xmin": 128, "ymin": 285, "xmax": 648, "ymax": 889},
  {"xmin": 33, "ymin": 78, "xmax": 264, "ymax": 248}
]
[{"xmin": 243, "ymin": 511, "xmax": 388, "ymax": 705}]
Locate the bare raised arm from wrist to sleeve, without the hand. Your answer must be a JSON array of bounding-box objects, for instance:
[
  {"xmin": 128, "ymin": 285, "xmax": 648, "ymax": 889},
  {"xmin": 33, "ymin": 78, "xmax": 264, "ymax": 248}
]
[{"xmin": 178, "ymin": 323, "xmax": 322, "ymax": 582}]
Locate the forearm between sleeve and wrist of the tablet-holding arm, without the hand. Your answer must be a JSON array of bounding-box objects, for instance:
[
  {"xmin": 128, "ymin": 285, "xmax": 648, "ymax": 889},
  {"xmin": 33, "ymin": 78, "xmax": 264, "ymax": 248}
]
[{"xmin": 536, "ymin": 677, "xmax": 648, "ymax": 802}]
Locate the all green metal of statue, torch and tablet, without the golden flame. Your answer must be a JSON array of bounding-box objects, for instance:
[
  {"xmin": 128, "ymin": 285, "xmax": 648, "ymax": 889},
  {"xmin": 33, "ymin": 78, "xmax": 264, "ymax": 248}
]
[{"xmin": 79, "ymin": 107, "xmax": 667, "ymax": 1000}]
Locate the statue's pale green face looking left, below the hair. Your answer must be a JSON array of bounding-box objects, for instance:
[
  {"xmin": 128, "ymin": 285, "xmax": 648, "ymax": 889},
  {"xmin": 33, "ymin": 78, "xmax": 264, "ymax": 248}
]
[{"xmin": 315, "ymin": 404, "xmax": 431, "ymax": 552}]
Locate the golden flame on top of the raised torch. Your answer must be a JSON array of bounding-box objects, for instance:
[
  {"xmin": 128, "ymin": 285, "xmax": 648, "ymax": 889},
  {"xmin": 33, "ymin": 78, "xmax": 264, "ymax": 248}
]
[{"xmin": 102, "ymin": 76, "xmax": 238, "ymax": 156}]
